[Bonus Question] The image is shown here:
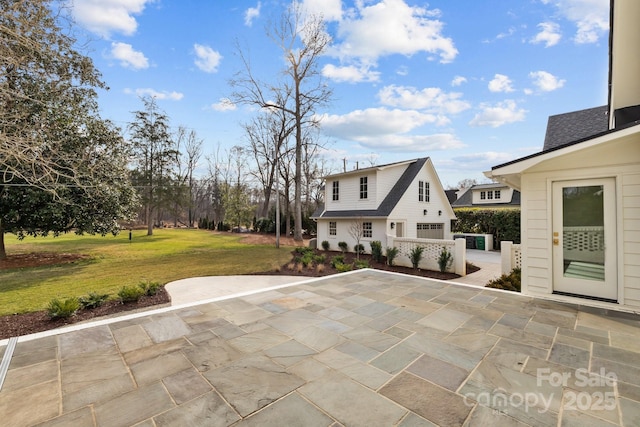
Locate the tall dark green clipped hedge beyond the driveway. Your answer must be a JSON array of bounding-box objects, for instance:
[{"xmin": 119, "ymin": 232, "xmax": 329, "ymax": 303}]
[{"xmin": 451, "ymin": 208, "xmax": 520, "ymax": 249}]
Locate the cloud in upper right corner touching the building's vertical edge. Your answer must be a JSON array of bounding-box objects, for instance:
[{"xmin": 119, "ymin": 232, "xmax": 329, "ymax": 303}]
[{"xmin": 546, "ymin": 0, "xmax": 609, "ymax": 44}]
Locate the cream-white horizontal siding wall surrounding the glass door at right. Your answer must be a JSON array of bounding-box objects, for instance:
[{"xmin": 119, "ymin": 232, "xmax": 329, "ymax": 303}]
[{"xmin": 521, "ymin": 134, "xmax": 640, "ymax": 310}]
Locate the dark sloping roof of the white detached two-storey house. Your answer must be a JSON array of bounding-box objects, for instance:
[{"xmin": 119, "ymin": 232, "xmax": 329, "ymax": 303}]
[{"xmin": 314, "ymin": 157, "xmax": 428, "ymax": 218}]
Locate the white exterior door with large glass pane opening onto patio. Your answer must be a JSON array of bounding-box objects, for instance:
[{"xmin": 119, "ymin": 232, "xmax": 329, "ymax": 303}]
[{"xmin": 552, "ymin": 178, "xmax": 618, "ymax": 301}]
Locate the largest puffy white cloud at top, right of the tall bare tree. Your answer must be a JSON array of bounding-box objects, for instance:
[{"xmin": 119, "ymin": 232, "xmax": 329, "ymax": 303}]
[{"xmin": 330, "ymin": 0, "xmax": 458, "ymax": 64}]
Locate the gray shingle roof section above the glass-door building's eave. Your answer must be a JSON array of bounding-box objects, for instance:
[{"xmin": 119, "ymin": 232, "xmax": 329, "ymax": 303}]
[{"xmin": 542, "ymin": 105, "xmax": 609, "ymax": 151}]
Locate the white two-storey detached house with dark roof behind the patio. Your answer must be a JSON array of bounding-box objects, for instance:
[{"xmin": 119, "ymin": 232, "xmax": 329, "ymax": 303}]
[{"xmin": 312, "ymin": 158, "xmax": 455, "ymax": 252}]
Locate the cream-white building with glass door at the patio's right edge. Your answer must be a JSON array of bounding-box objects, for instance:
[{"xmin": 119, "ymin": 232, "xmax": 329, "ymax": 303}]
[{"xmin": 485, "ymin": 0, "xmax": 640, "ymax": 312}]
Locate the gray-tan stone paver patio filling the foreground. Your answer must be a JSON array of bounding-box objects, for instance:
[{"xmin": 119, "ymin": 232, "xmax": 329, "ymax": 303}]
[{"xmin": 0, "ymin": 270, "xmax": 640, "ymax": 427}]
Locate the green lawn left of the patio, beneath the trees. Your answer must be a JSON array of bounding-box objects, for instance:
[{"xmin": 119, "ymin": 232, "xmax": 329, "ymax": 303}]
[{"xmin": 0, "ymin": 229, "xmax": 293, "ymax": 315}]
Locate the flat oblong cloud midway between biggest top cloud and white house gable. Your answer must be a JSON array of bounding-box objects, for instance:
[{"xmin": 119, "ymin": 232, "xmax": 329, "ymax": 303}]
[{"xmin": 378, "ymin": 85, "xmax": 471, "ymax": 114}]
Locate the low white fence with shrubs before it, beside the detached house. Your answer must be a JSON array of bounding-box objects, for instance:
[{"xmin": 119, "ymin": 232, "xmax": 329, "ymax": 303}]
[{"xmin": 387, "ymin": 235, "xmax": 467, "ymax": 276}]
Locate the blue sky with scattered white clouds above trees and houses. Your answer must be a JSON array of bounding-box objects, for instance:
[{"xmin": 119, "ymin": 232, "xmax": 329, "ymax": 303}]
[{"xmin": 72, "ymin": 0, "xmax": 609, "ymax": 187}]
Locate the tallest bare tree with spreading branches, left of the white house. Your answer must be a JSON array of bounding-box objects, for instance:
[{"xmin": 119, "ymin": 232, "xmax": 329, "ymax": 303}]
[{"xmin": 230, "ymin": 0, "xmax": 332, "ymax": 241}]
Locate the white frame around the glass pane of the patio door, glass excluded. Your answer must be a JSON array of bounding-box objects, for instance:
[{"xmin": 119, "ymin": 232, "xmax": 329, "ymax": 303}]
[{"xmin": 551, "ymin": 177, "xmax": 620, "ymax": 302}]
